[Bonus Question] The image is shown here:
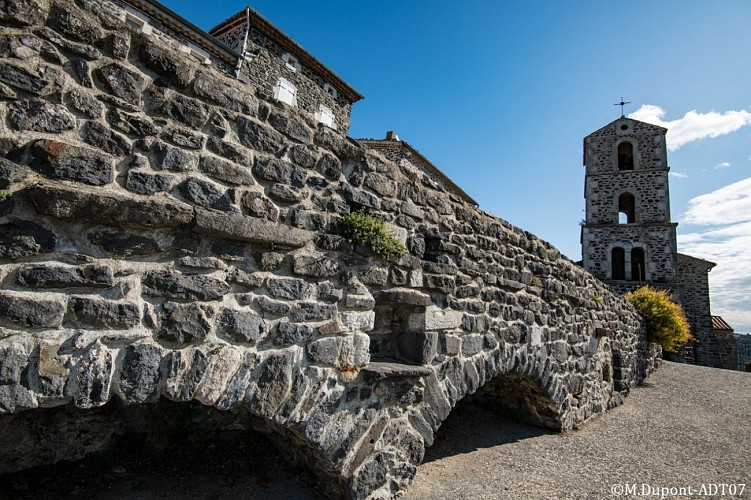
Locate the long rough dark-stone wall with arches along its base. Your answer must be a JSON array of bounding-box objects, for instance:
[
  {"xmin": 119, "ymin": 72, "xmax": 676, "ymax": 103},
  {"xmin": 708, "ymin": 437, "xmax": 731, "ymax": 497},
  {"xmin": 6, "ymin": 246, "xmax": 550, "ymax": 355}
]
[{"xmin": 0, "ymin": 0, "xmax": 656, "ymax": 498}]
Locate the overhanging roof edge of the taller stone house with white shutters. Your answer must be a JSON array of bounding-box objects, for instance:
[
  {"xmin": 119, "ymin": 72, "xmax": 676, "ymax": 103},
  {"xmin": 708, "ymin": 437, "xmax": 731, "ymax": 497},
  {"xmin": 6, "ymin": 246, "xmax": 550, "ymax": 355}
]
[{"xmin": 209, "ymin": 6, "xmax": 363, "ymax": 103}]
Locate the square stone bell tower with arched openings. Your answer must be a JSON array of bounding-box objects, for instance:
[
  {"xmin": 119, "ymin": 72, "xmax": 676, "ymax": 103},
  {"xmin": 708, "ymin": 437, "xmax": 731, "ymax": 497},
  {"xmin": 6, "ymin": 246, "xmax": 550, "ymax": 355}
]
[{"xmin": 581, "ymin": 116, "xmax": 678, "ymax": 292}]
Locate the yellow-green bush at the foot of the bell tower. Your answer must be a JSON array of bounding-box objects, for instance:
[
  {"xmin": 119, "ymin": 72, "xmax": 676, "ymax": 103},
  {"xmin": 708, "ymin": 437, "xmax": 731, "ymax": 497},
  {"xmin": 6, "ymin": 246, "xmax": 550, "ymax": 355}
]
[{"xmin": 626, "ymin": 286, "xmax": 691, "ymax": 353}]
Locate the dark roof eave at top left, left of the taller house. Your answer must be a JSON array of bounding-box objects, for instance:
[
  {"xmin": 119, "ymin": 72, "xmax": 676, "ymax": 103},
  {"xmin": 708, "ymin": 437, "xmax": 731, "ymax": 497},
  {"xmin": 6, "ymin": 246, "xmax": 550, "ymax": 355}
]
[{"xmin": 121, "ymin": 0, "xmax": 242, "ymax": 66}]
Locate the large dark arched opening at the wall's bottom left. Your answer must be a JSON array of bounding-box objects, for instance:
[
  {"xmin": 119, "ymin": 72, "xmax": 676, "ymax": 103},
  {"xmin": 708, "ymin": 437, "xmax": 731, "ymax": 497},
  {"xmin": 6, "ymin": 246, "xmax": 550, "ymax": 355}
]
[{"xmin": 0, "ymin": 398, "xmax": 314, "ymax": 498}]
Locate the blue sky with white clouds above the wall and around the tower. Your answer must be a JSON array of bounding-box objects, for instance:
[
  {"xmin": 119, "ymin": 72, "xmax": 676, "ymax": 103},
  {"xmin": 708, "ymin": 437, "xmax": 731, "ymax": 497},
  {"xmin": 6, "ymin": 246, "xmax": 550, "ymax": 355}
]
[{"xmin": 163, "ymin": 0, "xmax": 751, "ymax": 332}]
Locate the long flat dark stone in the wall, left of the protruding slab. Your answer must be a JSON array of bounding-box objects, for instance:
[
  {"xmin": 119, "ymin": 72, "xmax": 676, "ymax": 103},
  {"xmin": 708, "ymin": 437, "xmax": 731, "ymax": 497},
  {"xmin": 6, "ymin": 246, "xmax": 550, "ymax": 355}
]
[{"xmin": 28, "ymin": 186, "xmax": 193, "ymax": 228}]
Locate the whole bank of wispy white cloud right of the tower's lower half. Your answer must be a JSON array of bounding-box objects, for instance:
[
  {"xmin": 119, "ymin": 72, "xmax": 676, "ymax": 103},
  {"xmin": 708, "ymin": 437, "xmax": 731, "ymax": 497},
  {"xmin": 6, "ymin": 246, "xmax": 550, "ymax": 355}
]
[{"xmin": 678, "ymin": 178, "xmax": 751, "ymax": 332}]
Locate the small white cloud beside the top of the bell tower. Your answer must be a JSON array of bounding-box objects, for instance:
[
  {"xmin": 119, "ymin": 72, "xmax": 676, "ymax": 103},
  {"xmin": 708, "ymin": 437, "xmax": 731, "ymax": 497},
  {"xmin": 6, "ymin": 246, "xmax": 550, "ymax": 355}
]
[{"xmin": 628, "ymin": 104, "xmax": 751, "ymax": 151}]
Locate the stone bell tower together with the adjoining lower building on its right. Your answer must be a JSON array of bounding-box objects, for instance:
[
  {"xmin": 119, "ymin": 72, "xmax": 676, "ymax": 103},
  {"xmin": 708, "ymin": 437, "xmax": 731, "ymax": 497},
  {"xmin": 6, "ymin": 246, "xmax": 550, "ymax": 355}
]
[{"xmin": 581, "ymin": 116, "xmax": 735, "ymax": 369}]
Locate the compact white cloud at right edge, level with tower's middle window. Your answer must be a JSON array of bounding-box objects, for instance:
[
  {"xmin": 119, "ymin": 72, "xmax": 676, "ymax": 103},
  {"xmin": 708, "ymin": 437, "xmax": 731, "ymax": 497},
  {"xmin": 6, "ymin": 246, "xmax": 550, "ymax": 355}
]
[{"xmin": 682, "ymin": 177, "xmax": 751, "ymax": 225}]
